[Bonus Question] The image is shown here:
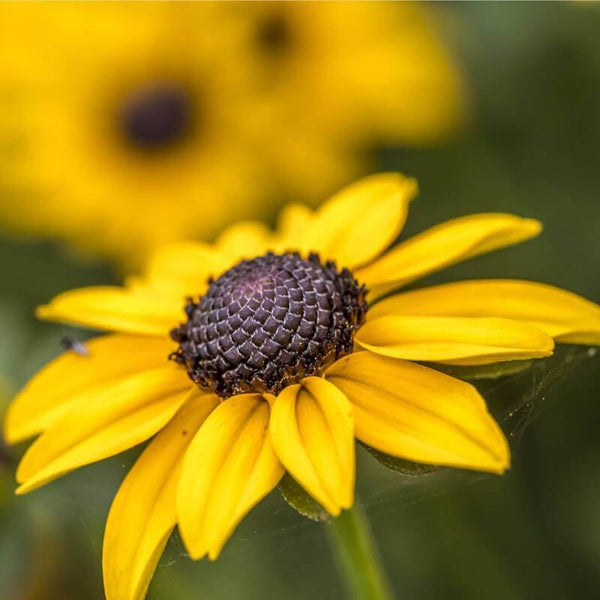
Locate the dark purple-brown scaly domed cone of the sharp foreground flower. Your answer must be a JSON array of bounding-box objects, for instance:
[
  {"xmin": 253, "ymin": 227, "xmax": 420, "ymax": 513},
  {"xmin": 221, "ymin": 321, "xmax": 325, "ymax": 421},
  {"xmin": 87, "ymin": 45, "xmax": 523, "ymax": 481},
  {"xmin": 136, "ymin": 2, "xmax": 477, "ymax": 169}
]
[{"xmin": 171, "ymin": 253, "xmax": 367, "ymax": 398}]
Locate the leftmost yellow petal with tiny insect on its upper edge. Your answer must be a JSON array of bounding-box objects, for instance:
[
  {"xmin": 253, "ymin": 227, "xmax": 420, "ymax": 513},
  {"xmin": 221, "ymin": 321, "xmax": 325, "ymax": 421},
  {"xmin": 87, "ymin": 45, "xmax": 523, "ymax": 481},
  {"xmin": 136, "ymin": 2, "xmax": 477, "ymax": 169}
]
[{"xmin": 4, "ymin": 334, "xmax": 174, "ymax": 443}]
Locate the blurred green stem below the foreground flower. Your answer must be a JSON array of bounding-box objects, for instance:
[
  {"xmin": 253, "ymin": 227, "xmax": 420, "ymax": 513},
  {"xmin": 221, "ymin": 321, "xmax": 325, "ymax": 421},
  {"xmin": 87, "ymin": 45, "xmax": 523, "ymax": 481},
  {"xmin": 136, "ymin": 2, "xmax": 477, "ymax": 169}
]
[{"xmin": 327, "ymin": 502, "xmax": 394, "ymax": 600}]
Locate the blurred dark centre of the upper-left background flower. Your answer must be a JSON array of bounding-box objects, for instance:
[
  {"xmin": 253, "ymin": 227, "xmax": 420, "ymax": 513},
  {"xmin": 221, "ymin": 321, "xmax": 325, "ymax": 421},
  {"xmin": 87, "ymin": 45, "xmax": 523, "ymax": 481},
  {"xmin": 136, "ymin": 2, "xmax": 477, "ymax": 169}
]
[{"xmin": 119, "ymin": 83, "xmax": 193, "ymax": 150}]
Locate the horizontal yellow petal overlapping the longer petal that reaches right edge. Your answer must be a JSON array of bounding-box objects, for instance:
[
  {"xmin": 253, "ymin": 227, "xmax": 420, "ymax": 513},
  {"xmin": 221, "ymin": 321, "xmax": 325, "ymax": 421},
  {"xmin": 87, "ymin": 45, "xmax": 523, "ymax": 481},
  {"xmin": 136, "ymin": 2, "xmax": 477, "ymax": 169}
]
[{"xmin": 355, "ymin": 315, "xmax": 554, "ymax": 365}]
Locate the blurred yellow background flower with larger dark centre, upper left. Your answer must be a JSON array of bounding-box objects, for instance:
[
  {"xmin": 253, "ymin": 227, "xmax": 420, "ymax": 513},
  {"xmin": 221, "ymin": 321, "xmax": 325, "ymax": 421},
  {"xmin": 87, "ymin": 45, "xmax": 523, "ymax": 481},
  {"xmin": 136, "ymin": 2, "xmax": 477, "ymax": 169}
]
[{"xmin": 0, "ymin": 2, "xmax": 261, "ymax": 265}]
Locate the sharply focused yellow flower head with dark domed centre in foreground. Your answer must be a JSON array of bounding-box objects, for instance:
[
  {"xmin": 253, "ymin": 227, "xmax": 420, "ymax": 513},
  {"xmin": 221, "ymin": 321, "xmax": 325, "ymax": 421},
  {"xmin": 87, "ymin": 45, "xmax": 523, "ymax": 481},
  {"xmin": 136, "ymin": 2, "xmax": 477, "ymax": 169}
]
[{"xmin": 5, "ymin": 173, "xmax": 600, "ymax": 600}]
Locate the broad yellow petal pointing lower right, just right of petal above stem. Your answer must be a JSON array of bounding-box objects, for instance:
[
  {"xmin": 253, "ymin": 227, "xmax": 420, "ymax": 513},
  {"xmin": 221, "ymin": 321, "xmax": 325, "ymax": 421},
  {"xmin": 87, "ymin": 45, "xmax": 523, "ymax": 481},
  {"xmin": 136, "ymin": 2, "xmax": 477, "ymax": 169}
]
[{"xmin": 325, "ymin": 352, "xmax": 510, "ymax": 473}]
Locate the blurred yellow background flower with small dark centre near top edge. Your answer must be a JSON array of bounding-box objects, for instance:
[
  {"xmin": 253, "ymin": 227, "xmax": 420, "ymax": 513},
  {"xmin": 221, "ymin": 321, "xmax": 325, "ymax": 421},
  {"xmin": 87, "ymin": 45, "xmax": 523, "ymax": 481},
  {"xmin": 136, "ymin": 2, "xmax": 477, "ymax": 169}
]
[{"xmin": 238, "ymin": 2, "xmax": 468, "ymax": 200}]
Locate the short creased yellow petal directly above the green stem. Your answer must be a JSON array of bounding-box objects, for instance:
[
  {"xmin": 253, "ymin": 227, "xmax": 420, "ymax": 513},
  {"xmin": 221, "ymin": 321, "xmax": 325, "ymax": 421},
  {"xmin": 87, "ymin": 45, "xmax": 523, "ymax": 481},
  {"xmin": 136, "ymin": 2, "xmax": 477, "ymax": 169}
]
[{"xmin": 270, "ymin": 377, "xmax": 355, "ymax": 515}]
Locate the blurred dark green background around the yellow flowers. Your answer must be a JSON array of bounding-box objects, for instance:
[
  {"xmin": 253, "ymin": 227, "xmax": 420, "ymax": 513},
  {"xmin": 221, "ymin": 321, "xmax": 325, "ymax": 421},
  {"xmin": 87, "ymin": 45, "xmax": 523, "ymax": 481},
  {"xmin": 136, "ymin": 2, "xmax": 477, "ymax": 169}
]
[{"xmin": 0, "ymin": 2, "xmax": 600, "ymax": 600}]
